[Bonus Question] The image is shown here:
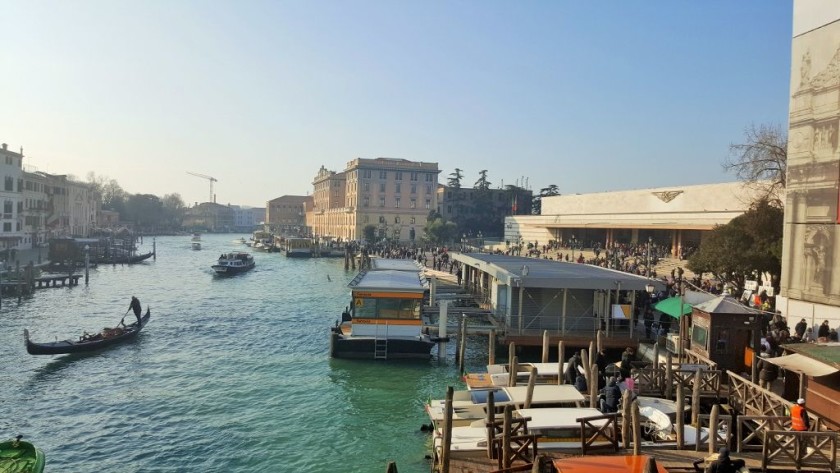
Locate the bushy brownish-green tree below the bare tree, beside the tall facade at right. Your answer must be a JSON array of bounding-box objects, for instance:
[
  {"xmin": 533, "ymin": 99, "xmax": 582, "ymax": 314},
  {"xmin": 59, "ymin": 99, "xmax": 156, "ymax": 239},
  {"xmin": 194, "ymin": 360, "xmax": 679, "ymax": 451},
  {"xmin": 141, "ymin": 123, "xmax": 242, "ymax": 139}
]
[{"xmin": 686, "ymin": 199, "xmax": 784, "ymax": 289}]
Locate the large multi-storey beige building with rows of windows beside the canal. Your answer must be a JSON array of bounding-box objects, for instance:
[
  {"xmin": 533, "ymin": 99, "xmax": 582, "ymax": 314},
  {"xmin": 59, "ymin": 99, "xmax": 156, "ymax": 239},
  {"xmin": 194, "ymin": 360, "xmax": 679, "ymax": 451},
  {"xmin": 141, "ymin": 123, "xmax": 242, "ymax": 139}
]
[{"xmin": 306, "ymin": 158, "xmax": 440, "ymax": 242}]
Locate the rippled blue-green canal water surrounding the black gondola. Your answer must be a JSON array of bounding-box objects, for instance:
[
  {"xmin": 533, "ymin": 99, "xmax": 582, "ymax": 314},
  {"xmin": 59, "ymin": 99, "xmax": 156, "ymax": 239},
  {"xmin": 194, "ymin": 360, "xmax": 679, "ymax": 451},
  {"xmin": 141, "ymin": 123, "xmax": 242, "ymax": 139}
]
[{"xmin": 0, "ymin": 235, "xmax": 487, "ymax": 473}]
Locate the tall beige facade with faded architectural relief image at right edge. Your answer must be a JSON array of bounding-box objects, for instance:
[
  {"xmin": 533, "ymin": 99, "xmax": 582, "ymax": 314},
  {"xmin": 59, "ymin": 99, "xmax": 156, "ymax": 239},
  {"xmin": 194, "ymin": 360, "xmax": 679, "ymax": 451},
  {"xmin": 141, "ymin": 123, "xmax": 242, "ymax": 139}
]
[{"xmin": 776, "ymin": 0, "xmax": 840, "ymax": 331}]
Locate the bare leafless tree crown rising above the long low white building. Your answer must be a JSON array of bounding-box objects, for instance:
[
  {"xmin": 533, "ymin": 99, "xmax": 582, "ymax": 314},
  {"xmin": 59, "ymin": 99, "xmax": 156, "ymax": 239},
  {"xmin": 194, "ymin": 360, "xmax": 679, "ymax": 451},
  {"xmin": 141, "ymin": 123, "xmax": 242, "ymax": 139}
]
[{"xmin": 723, "ymin": 124, "xmax": 787, "ymax": 201}]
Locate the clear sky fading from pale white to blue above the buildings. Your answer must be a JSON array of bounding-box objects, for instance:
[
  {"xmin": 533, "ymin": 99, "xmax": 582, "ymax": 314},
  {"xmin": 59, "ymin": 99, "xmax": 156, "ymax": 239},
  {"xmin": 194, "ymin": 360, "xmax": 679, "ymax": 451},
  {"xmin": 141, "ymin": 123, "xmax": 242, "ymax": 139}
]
[{"xmin": 0, "ymin": 0, "xmax": 792, "ymax": 207}]
